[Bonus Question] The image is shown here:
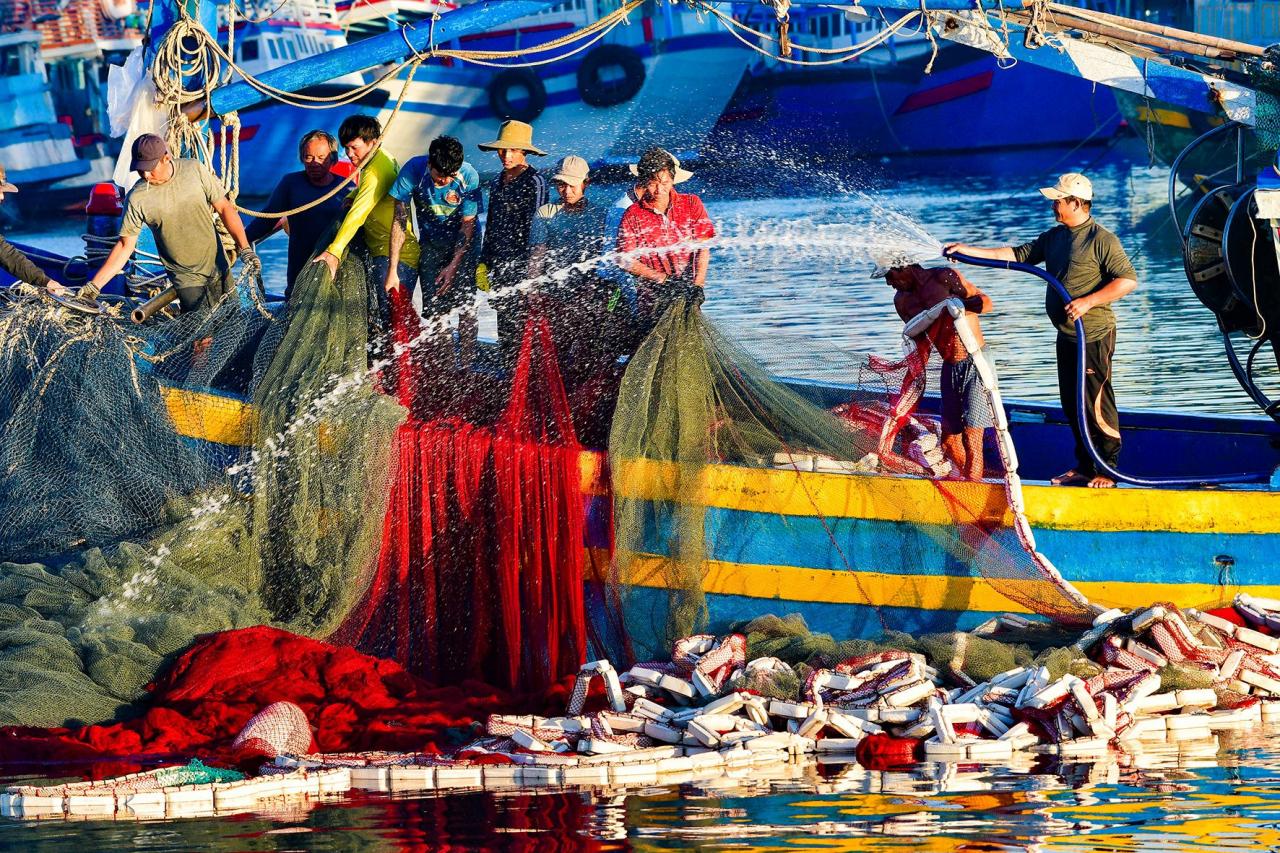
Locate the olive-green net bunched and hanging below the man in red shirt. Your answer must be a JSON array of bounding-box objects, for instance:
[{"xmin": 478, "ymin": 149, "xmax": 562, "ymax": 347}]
[{"xmin": 609, "ymin": 300, "xmax": 874, "ymax": 648}]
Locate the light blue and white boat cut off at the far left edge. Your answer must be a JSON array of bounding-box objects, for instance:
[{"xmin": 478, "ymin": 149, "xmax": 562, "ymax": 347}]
[{"xmin": 0, "ymin": 25, "xmax": 88, "ymax": 212}]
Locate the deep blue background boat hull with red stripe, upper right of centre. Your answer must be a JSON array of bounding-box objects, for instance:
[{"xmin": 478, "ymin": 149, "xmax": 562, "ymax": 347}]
[{"xmin": 713, "ymin": 4, "xmax": 1121, "ymax": 163}]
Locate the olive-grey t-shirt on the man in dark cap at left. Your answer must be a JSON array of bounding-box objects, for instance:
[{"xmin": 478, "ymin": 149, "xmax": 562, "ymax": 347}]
[{"xmin": 120, "ymin": 160, "xmax": 227, "ymax": 287}]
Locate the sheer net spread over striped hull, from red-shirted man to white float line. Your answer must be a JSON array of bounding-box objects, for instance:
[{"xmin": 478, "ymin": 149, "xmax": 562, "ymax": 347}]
[{"xmin": 609, "ymin": 285, "xmax": 1097, "ymax": 653}]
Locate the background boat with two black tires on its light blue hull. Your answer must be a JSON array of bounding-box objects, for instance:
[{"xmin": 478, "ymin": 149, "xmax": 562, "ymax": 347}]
[{"xmin": 342, "ymin": 0, "xmax": 749, "ymax": 172}]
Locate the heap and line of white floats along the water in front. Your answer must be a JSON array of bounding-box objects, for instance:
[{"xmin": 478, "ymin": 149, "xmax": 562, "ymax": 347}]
[{"xmin": 0, "ymin": 596, "xmax": 1280, "ymax": 818}]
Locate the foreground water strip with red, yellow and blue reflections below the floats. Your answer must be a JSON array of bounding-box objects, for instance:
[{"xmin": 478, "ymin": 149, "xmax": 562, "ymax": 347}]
[{"xmin": 12, "ymin": 726, "xmax": 1280, "ymax": 853}]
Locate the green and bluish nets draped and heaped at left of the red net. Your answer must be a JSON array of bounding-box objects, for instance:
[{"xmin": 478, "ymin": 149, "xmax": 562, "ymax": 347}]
[{"xmin": 0, "ymin": 255, "xmax": 403, "ymax": 726}]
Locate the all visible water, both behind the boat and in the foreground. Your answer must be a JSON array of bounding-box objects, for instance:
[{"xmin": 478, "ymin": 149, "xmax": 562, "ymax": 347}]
[{"xmin": 0, "ymin": 139, "xmax": 1280, "ymax": 850}]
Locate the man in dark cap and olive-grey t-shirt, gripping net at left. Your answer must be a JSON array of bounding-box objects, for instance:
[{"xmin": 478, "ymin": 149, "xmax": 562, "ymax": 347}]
[{"xmin": 79, "ymin": 133, "xmax": 262, "ymax": 311}]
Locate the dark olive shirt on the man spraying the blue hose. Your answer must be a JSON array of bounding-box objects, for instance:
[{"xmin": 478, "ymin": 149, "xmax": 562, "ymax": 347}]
[{"xmin": 1014, "ymin": 216, "xmax": 1138, "ymax": 342}]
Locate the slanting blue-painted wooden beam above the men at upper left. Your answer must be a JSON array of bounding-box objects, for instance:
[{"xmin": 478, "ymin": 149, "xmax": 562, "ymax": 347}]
[{"xmin": 210, "ymin": 0, "xmax": 553, "ymax": 115}]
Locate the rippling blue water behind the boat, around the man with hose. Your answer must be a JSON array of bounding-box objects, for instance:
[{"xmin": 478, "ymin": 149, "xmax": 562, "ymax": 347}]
[{"xmin": 13, "ymin": 137, "xmax": 1277, "ymax": 412}]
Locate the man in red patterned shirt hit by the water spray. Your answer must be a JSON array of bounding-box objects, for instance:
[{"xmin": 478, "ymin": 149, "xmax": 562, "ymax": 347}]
[{"xmin": 618, "ymin": 149, "xmax": 716, "ymax": 334}]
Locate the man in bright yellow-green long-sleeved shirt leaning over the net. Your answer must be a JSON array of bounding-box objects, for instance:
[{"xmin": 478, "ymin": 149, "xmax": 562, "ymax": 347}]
[{"xmin": 312, "ymin": 114, "xmax": 417, "ymax": 337}]
